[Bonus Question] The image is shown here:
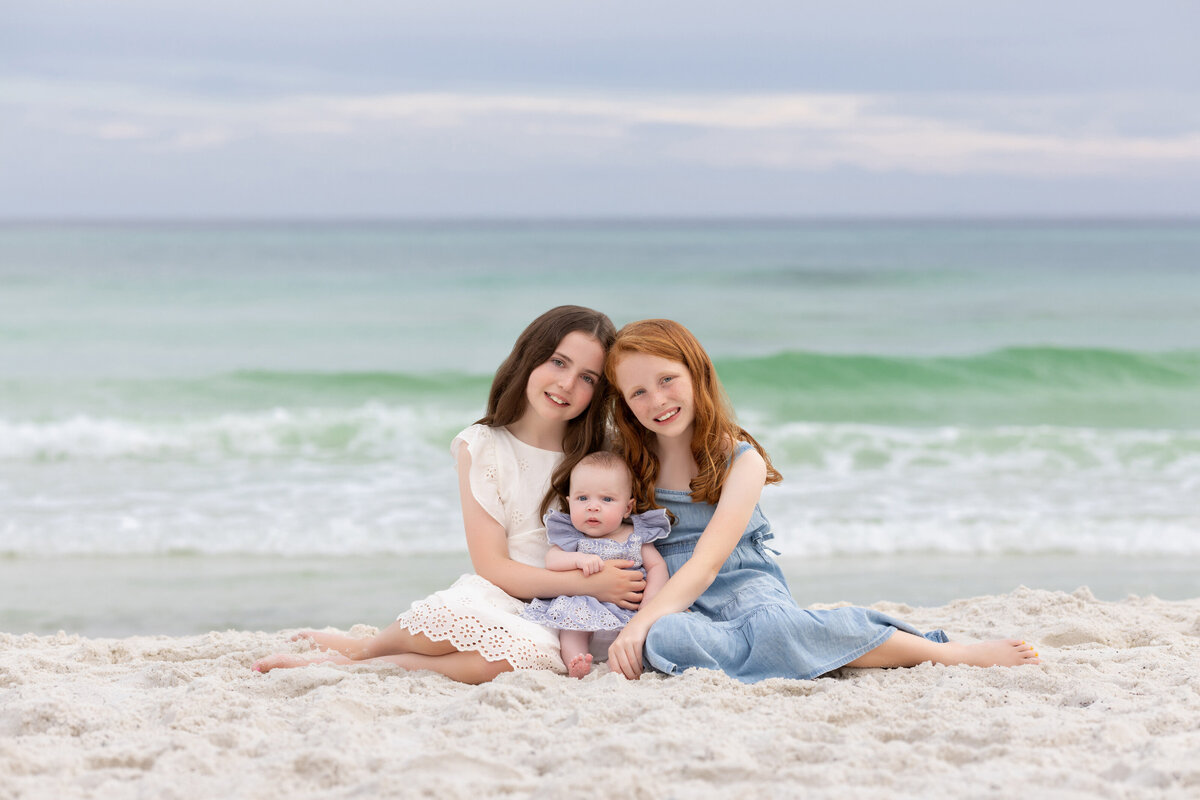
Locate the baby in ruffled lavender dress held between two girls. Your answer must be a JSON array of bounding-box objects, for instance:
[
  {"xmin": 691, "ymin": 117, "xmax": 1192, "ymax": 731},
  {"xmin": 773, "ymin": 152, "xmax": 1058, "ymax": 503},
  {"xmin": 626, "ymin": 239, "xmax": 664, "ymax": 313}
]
[{"xmin": 521, "ymin": 451, "xmax": 671, "ymax": 678}]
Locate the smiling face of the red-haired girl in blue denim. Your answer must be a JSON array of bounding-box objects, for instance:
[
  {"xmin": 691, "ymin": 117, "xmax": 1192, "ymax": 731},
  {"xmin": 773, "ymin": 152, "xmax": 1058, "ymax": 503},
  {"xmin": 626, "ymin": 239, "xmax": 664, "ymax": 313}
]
[{"xmin": 616, "ymin": 353, "xmax": 696, "ymax": 440}]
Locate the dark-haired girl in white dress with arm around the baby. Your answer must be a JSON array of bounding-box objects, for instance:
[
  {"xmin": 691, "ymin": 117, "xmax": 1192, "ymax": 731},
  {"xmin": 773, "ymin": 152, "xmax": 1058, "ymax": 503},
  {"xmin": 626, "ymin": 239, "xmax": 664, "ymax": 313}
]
[{"xmin": 254, "ymin": 306, "xmax": 646, "ymax": 684}]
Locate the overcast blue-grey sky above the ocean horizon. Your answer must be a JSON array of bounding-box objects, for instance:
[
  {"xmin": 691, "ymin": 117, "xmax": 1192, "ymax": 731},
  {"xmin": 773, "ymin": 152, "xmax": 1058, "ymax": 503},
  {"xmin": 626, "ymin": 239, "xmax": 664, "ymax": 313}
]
[{"xmin": 0, "ymin": 0, "xmax": 1200, "ymax": 218}]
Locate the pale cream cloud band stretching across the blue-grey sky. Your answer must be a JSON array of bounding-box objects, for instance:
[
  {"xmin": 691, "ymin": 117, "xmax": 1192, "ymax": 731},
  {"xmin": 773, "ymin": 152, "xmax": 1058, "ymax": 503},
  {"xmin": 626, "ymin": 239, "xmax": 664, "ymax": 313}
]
[{"xmin": 0, "ymin": 77, "xmax": 1200, "ymax": 175}]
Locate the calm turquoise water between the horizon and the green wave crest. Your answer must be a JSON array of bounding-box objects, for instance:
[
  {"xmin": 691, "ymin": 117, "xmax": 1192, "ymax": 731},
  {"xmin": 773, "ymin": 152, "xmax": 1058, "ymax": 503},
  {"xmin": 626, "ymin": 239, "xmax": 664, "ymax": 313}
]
[{"xmin": 7, "ymin": 222, "xmax": 1200, "ymax": 378}]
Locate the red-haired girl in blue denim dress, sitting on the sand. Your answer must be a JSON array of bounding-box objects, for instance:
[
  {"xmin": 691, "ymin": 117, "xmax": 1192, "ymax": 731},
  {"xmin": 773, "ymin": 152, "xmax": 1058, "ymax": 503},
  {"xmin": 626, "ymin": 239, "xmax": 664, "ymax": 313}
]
[{"xmin": 605, "ymin": 319, "xmax": 1038, "ymax": 682}]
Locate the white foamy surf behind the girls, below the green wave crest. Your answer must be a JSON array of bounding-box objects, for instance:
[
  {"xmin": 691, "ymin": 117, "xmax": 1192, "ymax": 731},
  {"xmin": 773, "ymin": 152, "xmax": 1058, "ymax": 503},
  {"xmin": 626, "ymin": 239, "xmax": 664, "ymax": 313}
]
[{"xmin": 0, "ymin": 403, "xmax": 1200, "ymax": 555}]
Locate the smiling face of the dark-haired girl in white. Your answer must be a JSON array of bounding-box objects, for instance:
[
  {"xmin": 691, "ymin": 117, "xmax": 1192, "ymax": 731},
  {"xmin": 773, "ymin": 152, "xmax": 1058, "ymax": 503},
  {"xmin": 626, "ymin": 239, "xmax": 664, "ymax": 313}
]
[{"xmin": 526, "ymin": 331, "xmax": 604, "ymax": 422}]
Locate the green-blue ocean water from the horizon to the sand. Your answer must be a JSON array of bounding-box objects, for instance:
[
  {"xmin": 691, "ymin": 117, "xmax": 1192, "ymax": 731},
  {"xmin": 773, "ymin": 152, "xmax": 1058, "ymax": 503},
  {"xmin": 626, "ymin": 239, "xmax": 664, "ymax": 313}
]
[{"xmin": 0, "ymin": 221, "xmax": 1200, "ymax": 632}]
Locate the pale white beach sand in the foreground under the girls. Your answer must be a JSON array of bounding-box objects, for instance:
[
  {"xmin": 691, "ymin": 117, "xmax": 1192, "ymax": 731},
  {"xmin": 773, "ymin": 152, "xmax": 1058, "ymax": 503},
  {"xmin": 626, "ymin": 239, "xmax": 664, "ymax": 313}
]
[{"xmin": 0, "ymin": 588, "xmax": 1200, "ymax": 800}]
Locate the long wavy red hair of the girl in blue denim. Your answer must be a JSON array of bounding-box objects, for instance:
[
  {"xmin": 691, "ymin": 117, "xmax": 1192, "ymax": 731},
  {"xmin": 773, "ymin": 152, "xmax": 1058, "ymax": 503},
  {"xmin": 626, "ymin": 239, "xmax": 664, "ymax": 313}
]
[{"xmin": 605, "ymin": 319, "xmax": 784, "ymax": 511}]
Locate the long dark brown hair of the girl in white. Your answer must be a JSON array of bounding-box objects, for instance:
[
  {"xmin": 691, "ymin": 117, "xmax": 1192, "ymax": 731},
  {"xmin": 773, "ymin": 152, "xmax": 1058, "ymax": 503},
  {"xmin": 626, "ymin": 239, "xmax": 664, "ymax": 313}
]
[{"xmin": 478, "ymin": 306, "xmax": 617, "ymax": 515}]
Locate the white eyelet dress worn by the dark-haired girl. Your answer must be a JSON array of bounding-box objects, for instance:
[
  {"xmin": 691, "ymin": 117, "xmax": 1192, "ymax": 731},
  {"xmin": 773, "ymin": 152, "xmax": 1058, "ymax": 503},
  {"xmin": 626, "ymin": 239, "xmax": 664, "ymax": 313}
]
[{"xmin": 396, "ymin": 425, "xmax": 566, "ymax": 673}]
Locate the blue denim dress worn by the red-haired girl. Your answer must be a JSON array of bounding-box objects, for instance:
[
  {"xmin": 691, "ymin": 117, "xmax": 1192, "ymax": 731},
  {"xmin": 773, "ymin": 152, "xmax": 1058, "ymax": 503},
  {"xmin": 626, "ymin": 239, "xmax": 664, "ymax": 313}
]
[{"xmin": 643, "ymin": 441, "xmax": 948, "ymax": 684}]
